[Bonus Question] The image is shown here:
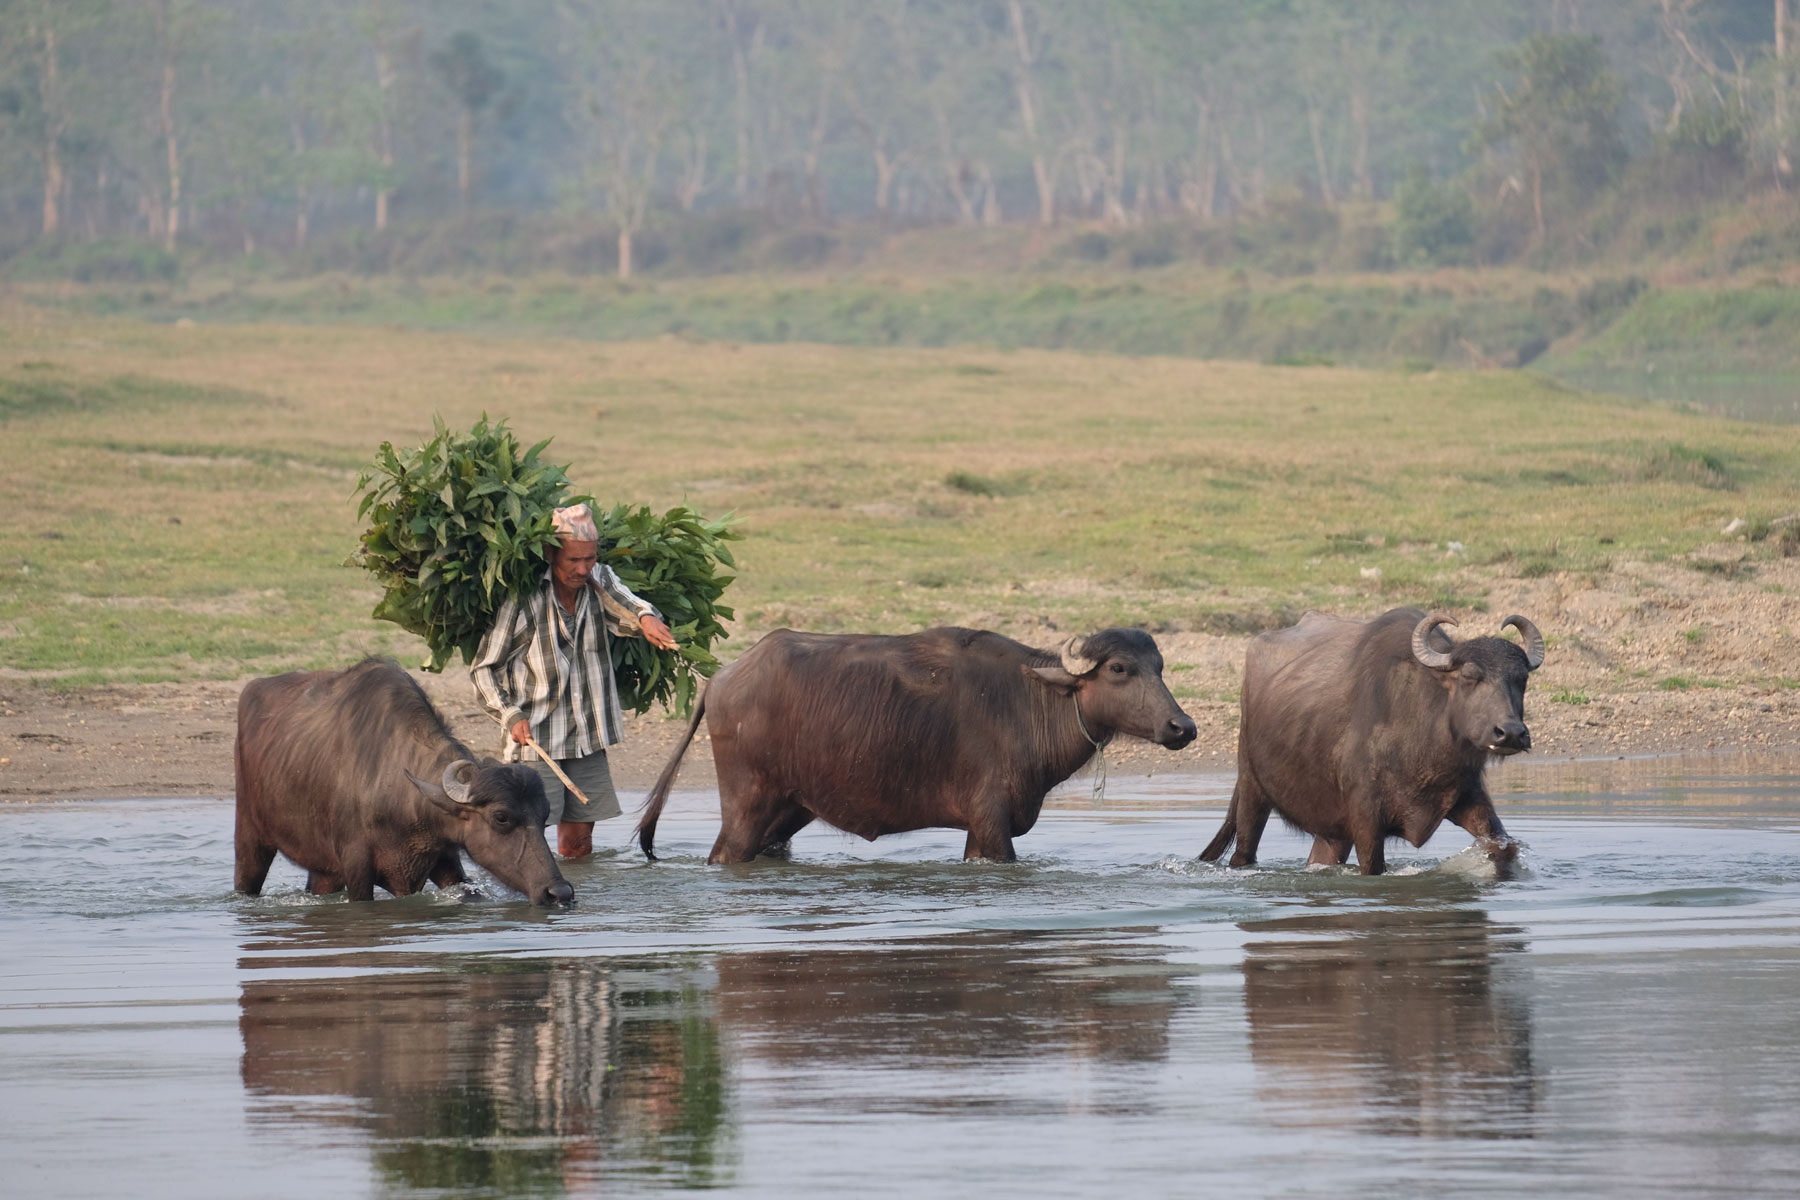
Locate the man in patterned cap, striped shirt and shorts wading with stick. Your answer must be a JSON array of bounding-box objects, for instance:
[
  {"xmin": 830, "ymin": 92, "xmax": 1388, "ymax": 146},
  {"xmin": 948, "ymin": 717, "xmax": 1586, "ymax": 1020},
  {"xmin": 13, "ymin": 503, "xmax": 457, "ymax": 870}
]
[{"xmin": 470, "ymin": 504, "xmax": 675, "ymax": 858}]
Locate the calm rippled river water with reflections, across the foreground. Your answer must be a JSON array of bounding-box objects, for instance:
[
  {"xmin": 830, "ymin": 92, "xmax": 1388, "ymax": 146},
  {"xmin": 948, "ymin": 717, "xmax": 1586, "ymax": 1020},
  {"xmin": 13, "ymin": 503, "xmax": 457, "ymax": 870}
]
[{"xmin": 0, "ymin": 756, "xmax": 1800, "ymax": 1200}]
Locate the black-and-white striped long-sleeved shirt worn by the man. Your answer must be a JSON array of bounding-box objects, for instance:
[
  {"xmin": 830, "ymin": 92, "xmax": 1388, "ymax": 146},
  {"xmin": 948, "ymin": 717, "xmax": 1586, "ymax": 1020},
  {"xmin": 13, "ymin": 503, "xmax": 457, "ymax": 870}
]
[{"xmin": 470, "ymin": 565, "xmax": 662, "ymax": 763}]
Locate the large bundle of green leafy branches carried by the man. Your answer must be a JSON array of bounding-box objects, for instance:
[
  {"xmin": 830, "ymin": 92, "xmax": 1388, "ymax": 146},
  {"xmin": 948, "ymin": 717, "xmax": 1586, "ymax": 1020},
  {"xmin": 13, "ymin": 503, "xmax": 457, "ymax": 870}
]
[{"xmin": 353, "ymin": 416, "xmax": 742, "ymax": 712}]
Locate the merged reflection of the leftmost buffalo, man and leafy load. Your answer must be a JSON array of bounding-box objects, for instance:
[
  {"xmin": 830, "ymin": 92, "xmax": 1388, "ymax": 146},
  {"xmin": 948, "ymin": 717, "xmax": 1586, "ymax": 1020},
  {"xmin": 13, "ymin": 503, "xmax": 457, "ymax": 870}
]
[{"xmin": 238, "ymin": 961, "xmax": 725, "ymax": 1193}]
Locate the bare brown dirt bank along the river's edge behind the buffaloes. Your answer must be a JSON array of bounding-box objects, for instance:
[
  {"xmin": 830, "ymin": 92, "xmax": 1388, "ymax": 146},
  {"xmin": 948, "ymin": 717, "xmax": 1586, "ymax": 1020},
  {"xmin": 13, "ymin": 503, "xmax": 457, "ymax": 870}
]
[{"xmin": 0, "ymin": 551, "xmax": 1800, "ymax": 802}]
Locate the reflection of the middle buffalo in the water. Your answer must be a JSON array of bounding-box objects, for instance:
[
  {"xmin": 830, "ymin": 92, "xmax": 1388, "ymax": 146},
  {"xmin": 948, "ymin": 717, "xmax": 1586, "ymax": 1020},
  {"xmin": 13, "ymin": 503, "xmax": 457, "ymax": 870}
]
[{"xmin": 718, "ymin": 932, "xmax": 1190, "ymax": 1069}]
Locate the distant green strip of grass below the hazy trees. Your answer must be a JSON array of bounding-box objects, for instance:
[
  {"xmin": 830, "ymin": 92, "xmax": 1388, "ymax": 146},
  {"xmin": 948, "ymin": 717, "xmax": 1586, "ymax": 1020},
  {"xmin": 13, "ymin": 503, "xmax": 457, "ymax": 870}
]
[{"xmin": 14, "ymin": 261, "xmax": 1800, "ymax": 425}]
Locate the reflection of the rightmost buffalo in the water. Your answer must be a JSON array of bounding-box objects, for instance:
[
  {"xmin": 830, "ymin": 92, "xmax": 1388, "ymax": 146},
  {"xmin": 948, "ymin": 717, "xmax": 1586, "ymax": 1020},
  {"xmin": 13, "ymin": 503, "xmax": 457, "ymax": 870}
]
[{"xmin": 1244, "ymin": 910, "xmax": 1537, "ymax": 1137}]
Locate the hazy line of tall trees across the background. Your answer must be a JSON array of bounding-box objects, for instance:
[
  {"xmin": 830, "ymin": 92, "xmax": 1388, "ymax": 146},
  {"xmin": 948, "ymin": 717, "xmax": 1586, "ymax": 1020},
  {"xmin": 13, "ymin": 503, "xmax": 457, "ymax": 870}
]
[{"xmin": 0, "ymin": 0, "xmax": 1800, "ymax": 275}]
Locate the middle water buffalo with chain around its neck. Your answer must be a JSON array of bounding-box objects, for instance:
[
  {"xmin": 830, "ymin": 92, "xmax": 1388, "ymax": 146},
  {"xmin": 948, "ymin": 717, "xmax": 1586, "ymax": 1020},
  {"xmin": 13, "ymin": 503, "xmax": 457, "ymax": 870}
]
[{"xmin": 637, "ymin": 628, "xmax": 1193, "ymax": 862}]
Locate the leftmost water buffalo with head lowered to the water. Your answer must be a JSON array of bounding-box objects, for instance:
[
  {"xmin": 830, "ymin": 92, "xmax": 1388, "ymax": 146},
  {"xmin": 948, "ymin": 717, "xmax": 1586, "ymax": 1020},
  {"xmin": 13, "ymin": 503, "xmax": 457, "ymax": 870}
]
[{"xmin": 236, "ymin": 658, "xmax": 574, "ymax": 905}]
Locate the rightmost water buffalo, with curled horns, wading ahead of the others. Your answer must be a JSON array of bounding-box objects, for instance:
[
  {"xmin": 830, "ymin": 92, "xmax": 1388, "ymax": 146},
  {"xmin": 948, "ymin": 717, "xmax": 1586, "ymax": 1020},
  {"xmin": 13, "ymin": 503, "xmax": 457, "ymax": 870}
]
[{"xmin": 1201, "ymin": 608, "xmax": 1544, "ymax": 874}]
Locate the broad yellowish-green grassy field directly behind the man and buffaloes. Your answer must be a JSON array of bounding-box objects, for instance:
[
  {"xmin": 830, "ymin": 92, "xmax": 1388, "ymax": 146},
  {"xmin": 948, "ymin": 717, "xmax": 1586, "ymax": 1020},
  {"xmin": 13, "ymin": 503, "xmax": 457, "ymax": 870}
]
[{"xmin": 0, "ymin": 302, "xmax": 1800, "ymax": 685}]
